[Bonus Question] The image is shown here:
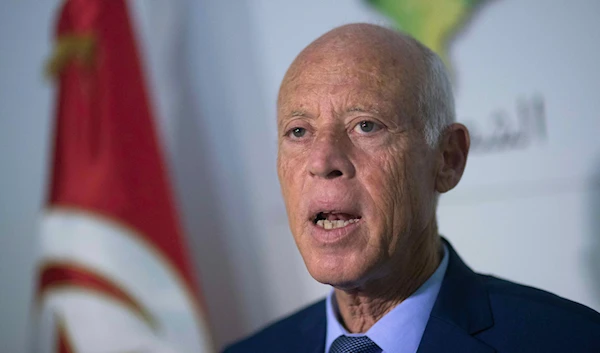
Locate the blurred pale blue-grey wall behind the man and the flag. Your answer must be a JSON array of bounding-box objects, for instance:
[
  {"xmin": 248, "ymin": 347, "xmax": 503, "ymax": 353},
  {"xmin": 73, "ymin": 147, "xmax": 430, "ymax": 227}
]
[{"xmin": 0, "ymin": 0, "xmax": 600, "ymax": 353}]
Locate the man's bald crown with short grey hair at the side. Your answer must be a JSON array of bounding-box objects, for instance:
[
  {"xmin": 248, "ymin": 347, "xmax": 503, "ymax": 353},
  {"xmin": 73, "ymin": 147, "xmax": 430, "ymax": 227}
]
[{"xmin": 278, "ymin": 24, "xmax": 455, "ymax": 147}]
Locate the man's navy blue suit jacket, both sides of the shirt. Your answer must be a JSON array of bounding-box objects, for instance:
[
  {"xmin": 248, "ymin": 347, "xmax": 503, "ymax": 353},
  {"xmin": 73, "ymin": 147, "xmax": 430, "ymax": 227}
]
[{"xmin": 225, "ymin": 243, "xmax": 600, "ymax": 353}]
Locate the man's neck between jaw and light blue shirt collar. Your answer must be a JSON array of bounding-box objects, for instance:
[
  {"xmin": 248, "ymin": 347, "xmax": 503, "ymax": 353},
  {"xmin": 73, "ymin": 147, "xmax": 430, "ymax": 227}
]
[{"xmin": 335, "ymin": 227, "xmax": 443, "ymax": 333}]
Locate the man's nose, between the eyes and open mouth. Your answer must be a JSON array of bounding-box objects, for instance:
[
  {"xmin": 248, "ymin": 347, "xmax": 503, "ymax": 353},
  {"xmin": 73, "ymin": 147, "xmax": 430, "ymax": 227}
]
[{"xmin": 308, "ymin": 129, "xmax": 356, "ymax": 179}]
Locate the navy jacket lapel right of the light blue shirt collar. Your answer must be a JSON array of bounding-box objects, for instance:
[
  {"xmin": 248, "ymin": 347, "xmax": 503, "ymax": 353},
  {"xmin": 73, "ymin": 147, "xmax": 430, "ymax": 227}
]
[{"xmin": 417, "ymin": 239, "xmax": 494, "ymax": 353}]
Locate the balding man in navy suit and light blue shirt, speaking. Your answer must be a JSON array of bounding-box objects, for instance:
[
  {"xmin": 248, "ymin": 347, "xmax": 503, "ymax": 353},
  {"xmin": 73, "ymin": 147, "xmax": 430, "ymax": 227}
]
[{"xmin": 226, "ymin": 24, "xmax": 600, "ymax": 353}]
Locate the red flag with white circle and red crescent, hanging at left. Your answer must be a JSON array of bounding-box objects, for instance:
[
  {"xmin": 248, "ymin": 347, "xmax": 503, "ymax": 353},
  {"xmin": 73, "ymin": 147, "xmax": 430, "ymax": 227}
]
[{"xmin": 35, "ymin": 0, "xmax": 212, "ymax": 353}]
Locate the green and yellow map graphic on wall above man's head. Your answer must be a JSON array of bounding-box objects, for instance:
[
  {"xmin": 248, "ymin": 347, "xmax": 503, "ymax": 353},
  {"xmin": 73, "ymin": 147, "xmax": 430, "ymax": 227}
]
[{"xmin": 367, "ymin": 0, "xmax": 489, "ymax": 71}]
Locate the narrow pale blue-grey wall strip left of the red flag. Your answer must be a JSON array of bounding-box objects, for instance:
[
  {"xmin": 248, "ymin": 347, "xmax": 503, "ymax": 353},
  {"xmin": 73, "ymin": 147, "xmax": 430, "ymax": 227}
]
[{"xmin": 0, "ymin": 1, "xmax": 58, "ymax": 353}]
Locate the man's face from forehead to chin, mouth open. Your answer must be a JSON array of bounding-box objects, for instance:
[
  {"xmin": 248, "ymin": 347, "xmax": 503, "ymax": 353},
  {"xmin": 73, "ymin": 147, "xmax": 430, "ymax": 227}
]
[{"xmin": 277, "ymin": 55, "xmax": 435, "ymax": 289}]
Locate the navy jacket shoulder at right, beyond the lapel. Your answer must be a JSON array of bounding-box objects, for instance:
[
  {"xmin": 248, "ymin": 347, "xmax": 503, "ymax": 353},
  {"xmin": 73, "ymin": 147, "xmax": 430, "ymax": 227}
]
[{"xmin": 479, "ymin": 275, "xmax": 600, "ymax": 351}]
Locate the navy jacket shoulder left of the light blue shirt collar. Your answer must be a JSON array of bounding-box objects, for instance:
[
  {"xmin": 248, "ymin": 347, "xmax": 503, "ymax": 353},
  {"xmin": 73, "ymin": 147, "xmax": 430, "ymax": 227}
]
[{"xmin": 224, "ymin": 300, "xmax": 326, "ymax": 353}]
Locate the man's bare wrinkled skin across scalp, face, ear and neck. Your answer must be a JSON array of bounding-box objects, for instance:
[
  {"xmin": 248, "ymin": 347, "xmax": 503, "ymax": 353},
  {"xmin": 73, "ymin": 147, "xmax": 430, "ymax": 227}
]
[{"xmin": 277, "ymin": 25, "xmax": 468, "ymax": 332}]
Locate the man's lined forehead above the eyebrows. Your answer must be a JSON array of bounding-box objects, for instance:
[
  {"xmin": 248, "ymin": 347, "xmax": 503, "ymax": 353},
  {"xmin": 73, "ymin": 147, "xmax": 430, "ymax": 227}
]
[{"xmin": 278, "ymin": 51, "xmax": 418, "ymax": 119}]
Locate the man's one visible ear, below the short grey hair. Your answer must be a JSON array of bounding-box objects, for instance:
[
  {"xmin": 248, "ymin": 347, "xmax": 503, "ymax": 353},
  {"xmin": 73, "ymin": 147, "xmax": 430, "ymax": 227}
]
[{"xmin": 435, "ymin": 123, "xmax": 471, "ymax": 193}]
